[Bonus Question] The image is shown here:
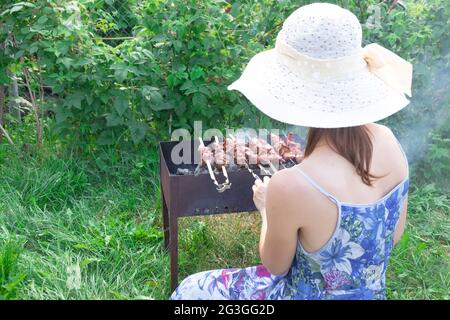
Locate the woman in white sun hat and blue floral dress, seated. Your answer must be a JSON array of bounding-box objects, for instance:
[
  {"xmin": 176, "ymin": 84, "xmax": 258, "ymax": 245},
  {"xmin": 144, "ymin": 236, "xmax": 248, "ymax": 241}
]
[{"xmin": 171, "ymin": 4, "xmax": 412, "ymax": 299}]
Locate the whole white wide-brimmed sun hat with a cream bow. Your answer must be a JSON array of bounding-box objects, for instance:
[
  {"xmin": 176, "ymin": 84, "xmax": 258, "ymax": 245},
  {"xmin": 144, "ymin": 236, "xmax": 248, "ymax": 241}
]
[{"xmin": 228, "ymin": 3, "xmax": 412, "ymax": 128}]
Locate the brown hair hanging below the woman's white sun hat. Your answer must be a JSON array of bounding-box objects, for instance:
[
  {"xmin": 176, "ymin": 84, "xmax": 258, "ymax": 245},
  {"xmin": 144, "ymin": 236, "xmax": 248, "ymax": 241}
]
[{"xmin": 305, "ymin": 126, "xmax": 380, "ymax": 186}]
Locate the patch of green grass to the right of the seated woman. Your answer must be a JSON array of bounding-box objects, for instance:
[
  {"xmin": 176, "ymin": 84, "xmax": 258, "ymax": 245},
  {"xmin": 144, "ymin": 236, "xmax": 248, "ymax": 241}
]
[{"xmin": 387, "ymin": 185, "xmax": 450, "ymax": 299}]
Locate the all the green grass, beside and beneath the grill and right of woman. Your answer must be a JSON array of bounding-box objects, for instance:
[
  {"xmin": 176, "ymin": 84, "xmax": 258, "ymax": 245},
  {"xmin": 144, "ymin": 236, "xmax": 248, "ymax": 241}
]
[{"xmin": 0, "ymin": 140, "xmax": 450, "ymax": 299}]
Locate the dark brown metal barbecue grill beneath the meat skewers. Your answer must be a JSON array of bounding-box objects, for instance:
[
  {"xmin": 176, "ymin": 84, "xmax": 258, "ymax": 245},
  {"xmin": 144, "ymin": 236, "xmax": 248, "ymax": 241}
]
[{"xmin": 159, "ymin": 134, "xmax": 304, "ymax": 290}]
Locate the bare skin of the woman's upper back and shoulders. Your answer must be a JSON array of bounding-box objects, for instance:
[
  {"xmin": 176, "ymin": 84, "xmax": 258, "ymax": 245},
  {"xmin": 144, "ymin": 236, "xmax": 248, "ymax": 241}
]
[{"xmin": 283, "ymin": 124, "xmax": 408, "ymax": 252}]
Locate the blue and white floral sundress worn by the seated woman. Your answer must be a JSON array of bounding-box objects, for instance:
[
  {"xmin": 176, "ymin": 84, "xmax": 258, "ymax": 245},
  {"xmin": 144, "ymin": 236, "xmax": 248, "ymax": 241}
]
[{"xmin": 171, "ymin": 150, "xmax": 409, "ymax": 300}]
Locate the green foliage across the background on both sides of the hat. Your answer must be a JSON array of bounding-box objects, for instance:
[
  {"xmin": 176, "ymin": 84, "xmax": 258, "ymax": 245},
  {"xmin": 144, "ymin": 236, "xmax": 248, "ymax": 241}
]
[{"xmin": 0, "ymin": 0, "xmax": 450, "ymax": 152}]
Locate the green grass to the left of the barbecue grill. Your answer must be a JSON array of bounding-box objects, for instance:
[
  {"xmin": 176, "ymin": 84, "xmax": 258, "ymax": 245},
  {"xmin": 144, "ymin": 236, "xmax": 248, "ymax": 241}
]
[{"xmin": 0, "ymin": 142, "xmax": 169, "ymax": 299}]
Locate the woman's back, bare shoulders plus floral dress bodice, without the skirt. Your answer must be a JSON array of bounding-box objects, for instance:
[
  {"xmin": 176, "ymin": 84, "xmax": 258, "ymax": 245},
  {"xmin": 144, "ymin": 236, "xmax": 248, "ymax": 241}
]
[{"xmin": 268, "ymin": 124, "xmax": 408, "ymax": 299}]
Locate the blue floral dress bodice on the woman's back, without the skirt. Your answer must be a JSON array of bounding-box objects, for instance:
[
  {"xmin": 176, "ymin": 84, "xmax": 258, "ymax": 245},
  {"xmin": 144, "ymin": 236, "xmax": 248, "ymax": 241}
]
[{"xmin": 267, "ymin": 178, "xmax": 408, "ymax": 300}]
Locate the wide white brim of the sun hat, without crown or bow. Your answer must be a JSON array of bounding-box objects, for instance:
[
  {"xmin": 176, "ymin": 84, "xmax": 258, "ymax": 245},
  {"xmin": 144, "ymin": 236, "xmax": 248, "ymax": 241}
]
[{"xmin": 228, "ymin": 49, "xmax": 409, "ymax": 128}]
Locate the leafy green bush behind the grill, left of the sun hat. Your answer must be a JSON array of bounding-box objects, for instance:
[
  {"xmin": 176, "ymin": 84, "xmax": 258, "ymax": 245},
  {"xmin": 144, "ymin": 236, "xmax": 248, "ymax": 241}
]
[{"xmin": 2, "ymin": 1, "xmax": 290, "ymax": 144}]
